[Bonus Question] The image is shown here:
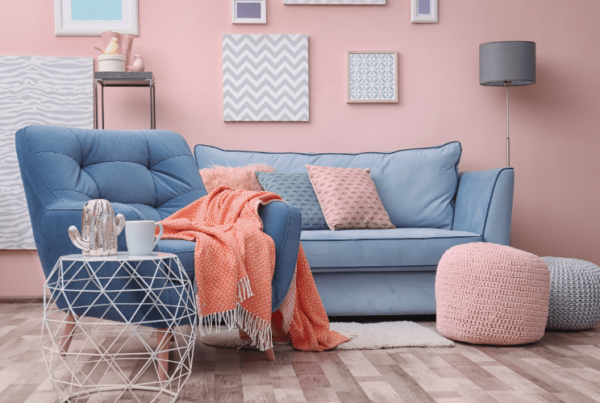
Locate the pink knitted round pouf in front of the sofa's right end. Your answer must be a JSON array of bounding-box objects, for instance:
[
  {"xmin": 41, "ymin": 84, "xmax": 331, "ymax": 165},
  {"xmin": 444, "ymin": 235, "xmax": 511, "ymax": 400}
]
[{"xmin": 435, "ymin": 242, "xmax": 550, "ymax": 345}]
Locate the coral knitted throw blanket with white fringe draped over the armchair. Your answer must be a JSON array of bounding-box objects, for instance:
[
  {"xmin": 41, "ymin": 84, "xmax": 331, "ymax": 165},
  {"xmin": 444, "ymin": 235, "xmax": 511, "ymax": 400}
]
[{"xmin": 161, "ymin": 186, "xmax": 350, "ymax": 351}]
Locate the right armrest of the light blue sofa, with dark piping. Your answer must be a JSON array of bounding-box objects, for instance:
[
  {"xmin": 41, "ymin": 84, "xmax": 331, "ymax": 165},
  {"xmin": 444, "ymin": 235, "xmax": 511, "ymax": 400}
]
[{"xmin": 452, "ymin": 168, "xmax": 515, "ymax": 245}]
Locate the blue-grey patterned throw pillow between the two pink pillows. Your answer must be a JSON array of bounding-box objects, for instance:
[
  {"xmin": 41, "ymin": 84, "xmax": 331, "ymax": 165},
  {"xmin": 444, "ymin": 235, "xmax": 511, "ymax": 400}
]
[{"xmin": 256, "ymin": 172, "xmax": 327, "ymax": 230}]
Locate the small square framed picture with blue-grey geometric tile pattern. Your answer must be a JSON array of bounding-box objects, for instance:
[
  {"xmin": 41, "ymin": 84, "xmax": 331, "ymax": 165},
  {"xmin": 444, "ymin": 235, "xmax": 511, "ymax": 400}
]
[{"xmin": 346, "ymin": 51, "xmax": 398, "ymax": 104}]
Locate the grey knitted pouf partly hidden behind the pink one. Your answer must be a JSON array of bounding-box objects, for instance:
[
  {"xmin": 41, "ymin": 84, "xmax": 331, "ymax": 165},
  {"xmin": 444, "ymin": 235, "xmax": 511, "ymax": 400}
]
[{"xmin": 542, "ymin": 257, "xmax": 600, "ymax": 330}]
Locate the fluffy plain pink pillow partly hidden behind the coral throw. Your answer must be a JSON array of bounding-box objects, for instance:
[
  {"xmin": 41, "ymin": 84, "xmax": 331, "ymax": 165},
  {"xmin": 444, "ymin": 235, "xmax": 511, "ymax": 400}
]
[{"xmin": 200, "ymin": 164, "xmax": 275, "ymax": 193}]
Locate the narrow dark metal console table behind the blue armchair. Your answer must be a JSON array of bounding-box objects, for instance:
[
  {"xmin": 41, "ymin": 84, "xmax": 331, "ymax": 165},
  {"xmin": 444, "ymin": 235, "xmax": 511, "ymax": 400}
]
[{"xmin": 94, "ymin": 71, "xmax": 156, "ymax": 130}]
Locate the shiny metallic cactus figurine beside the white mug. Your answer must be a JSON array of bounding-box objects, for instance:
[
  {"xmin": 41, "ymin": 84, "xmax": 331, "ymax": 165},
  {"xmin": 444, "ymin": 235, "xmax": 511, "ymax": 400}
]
[{"xmin": 69, "ymin": 199, "xmax": 125, "ymax": 256}]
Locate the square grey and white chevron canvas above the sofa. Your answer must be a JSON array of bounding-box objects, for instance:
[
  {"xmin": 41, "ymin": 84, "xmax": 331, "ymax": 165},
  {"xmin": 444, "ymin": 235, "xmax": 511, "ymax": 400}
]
[{"xmin": 223, "ymin": 35, "xmax": 309, "ymax": 122}]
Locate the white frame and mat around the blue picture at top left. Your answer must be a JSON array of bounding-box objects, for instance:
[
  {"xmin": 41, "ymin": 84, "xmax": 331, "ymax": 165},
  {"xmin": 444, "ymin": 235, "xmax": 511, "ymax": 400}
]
[{"xmin": 54, "ymin": 0, "xmax": 140, "ymax": 36}]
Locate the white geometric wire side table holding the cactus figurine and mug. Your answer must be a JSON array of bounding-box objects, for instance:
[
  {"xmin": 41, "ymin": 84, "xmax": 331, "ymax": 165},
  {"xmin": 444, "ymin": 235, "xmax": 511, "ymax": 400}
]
[{"xmin": 41, "ymin": 253, "xmax": 198, "ymax": 403}]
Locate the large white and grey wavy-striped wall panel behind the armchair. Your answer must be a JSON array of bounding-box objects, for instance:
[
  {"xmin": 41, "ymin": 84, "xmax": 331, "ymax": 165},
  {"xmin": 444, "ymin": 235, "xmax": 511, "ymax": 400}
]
[{"xmin": 0, "ymin": 56, "xmax": 94, "ymax": 249}]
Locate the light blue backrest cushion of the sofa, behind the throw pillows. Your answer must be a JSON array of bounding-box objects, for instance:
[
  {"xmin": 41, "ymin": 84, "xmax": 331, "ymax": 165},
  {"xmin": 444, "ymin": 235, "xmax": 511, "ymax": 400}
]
[{"xmin": 194, "ymin": 142, "xmax": 462, "ymax": 229}]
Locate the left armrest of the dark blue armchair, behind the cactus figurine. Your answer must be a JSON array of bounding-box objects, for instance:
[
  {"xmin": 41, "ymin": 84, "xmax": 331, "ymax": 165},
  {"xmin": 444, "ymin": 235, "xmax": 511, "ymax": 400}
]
[{"xmin": 36, "ymin": 200, "xmax": 144, "ymax": 276}]
